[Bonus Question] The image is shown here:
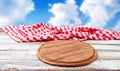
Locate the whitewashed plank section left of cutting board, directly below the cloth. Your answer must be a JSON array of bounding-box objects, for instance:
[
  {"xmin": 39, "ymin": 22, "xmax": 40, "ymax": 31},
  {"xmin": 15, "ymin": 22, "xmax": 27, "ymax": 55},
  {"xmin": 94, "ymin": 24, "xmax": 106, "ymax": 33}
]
[{"xmin": 0, "ymin": 42, "xmax": 44, "ymax": 51}]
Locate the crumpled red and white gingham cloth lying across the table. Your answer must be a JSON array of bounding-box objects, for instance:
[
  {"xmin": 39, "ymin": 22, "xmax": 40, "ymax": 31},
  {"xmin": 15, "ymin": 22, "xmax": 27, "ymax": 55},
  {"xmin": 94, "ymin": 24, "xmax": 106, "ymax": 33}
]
[{"xmin": 1, "ymin": 23, "xmax": 120, "ymax": 42}]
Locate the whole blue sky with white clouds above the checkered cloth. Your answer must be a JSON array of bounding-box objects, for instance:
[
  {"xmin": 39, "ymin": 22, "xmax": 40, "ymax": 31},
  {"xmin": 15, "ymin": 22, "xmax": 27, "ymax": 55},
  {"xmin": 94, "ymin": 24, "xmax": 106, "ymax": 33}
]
[{"xmin": 0, "ymin": 0, "xmax": 120, "ymax": 31}]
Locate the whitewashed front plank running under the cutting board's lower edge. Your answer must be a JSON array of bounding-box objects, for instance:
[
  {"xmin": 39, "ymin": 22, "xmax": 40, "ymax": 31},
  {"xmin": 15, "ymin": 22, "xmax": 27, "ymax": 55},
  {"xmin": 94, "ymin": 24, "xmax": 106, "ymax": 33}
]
[{"xmin": 0, "ymin": 60, "xmax": 120, "ymax": 71}]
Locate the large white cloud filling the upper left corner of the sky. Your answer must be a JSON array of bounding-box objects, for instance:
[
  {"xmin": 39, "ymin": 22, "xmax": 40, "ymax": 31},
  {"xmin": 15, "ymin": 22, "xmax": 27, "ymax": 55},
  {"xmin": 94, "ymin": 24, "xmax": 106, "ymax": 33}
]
[{"xmin": 0, "ymin": 0, "xmax": 34, "ymax": 27}]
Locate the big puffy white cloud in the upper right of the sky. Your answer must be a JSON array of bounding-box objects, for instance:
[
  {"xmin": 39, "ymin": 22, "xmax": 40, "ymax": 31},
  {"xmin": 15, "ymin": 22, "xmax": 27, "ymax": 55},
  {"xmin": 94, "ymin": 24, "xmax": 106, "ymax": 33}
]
[{"xmin": 80, "ymin": 0, "xmax": 120, "ymax": 28}]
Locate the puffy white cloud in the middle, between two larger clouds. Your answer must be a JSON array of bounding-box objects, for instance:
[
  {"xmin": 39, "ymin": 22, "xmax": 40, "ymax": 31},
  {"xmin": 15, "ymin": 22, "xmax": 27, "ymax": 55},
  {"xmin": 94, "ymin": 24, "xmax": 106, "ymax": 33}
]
[{"xmin": 48, "ymin": 0, "xmax": 81, "ymax": 26}]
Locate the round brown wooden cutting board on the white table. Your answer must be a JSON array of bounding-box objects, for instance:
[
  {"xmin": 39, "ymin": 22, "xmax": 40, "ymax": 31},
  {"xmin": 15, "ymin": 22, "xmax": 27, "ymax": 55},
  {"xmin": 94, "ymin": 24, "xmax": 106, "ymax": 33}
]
[{"xmin": 37, "ymin": 40, "xmax": 97, "ymax": 66}]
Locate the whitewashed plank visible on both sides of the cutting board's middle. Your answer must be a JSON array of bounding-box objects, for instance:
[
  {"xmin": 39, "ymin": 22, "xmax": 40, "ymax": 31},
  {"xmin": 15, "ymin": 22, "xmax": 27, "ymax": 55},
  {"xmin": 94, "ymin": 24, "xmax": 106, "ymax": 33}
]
[{"xmin": 0, "ymin": 50, "xmax": 120, "ymax": 60}]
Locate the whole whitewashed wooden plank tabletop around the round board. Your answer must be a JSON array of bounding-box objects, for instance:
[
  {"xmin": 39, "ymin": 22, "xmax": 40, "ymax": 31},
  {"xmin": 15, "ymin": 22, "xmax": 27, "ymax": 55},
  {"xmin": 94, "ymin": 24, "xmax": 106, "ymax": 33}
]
[{"xmin": 0, "ymin": 32, "xmax": 120, "ymax": 71}]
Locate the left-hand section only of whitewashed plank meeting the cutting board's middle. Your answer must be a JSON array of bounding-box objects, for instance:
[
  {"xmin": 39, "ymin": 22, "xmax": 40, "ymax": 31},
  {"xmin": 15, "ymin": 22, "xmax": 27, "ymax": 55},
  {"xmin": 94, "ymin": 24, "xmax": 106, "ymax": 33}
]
[{"xmin": 0, "ymin": 51, "xmax": 38, "ymax": 60}]
